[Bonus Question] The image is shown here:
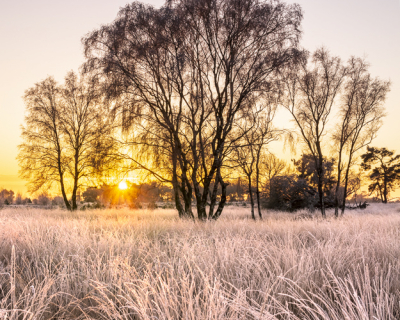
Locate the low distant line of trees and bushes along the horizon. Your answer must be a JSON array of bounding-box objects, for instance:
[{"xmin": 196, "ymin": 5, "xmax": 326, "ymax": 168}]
[{"xmin": 0, "ymin": 148, "xmax": 400, "ymax": 211}]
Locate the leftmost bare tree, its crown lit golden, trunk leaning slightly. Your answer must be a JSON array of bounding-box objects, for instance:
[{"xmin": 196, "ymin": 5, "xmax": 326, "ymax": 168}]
[{"xmin": 17, "ymin": 77, "xmax": 71, "ymax": 210}]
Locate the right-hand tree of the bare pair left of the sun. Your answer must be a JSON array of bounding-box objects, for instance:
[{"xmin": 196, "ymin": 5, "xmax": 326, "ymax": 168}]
[{"xmin": 60, "ymin": 72, "xmax": 117, "ymax": 210}]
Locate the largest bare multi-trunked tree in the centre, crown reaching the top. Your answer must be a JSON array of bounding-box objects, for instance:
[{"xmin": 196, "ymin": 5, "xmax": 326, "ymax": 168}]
[{"xmin": 83, "ymin": 0, "xmax": 302, "ymax": 220}]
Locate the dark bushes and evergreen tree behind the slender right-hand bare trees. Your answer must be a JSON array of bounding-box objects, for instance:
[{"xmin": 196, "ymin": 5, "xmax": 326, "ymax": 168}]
[{"xmin": 262, "ymin": 147, "xmax": 400, "ymax": 211}]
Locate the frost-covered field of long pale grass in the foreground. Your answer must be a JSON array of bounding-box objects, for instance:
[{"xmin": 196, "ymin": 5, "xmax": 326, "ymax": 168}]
[{"xmin": 0, "ymin": 204, "xmax": 400, "ymax": 320}]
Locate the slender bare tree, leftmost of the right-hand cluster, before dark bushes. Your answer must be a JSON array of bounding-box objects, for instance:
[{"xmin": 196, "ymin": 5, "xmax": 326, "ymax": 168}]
[{"xmin": 284, "ymin": 48, "xmax": 347, "ymax": 217}]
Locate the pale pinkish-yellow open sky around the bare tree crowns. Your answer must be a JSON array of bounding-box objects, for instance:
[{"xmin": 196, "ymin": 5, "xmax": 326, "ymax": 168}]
[{"xmin": 0, "ymin": 0, "xmax": 400, "ymax": 192}]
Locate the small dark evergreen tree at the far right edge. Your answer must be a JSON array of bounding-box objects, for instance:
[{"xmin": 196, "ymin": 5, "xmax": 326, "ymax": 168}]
[{"xmin": 361, "ymin": 147, "xmax": 400, "ymax": 203}]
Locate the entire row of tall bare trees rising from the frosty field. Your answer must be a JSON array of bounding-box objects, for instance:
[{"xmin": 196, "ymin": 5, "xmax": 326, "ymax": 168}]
[{"xmin": 18, "ymin": 0, "xmax": 397, "ymax": 220}]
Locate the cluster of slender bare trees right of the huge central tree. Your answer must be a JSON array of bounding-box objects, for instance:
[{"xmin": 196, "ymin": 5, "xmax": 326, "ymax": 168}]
[{"xmin": 284, "ymin": 49, "xmax": 390, "ymax": 216}]
